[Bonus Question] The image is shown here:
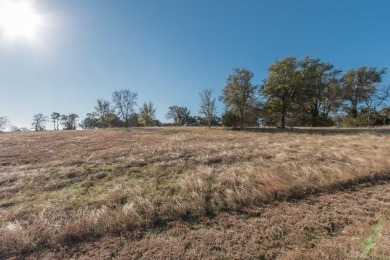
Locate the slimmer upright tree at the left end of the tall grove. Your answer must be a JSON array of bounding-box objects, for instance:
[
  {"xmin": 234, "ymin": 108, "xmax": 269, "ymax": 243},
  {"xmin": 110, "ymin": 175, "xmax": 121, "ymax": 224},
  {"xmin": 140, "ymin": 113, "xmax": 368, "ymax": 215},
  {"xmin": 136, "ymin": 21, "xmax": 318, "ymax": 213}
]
[{"xmin": 221, "ymin": 69, "xmax": 257, "ymax": 129}]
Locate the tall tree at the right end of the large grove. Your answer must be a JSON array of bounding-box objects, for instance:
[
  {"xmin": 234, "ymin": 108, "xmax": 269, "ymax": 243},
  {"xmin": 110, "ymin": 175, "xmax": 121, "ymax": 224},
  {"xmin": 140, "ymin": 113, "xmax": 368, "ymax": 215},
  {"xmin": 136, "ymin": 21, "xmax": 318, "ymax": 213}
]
[{"xmin": 341, "ymin": 67, "xmax": 386, "ymax": 119}]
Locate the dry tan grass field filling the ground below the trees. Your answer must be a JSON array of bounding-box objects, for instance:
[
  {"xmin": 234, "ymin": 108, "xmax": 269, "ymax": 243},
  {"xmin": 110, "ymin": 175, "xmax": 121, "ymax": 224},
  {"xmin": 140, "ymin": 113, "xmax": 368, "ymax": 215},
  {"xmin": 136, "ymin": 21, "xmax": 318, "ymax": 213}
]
[{"xmin": 0, "ymin": 128, "xmax": 390, "ymax": 259}]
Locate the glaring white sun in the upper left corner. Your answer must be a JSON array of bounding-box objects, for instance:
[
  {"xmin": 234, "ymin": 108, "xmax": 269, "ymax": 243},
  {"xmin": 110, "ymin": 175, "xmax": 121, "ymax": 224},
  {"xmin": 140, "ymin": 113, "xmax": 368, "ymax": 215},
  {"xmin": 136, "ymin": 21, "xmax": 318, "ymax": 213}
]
[{"xmin": 0, "ymin": 0, "xmax": 43, "ymax": 41}]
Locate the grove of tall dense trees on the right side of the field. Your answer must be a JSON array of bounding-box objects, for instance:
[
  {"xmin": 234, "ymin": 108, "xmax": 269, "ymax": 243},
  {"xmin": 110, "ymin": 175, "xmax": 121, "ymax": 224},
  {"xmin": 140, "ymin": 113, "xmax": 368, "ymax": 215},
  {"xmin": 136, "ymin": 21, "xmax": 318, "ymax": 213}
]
[{"xmin": 221, "ymin": 56, "xmax": 390, "ymax": 128}]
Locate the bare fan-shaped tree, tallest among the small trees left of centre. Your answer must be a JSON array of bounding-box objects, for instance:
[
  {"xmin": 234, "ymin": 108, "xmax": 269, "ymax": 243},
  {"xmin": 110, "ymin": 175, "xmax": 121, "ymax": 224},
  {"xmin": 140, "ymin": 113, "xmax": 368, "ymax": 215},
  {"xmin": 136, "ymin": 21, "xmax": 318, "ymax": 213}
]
[{"xmin": 112, "ymin": 89, "xmax": 137, "ymax": 127}]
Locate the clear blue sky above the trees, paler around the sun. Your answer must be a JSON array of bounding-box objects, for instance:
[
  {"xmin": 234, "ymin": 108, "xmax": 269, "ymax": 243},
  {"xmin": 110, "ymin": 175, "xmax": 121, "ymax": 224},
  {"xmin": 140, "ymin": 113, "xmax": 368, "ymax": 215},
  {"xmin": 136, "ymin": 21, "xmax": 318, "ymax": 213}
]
[{"xmin": 0, "ymin": 0, "xmax": 390, "ymax": 130}]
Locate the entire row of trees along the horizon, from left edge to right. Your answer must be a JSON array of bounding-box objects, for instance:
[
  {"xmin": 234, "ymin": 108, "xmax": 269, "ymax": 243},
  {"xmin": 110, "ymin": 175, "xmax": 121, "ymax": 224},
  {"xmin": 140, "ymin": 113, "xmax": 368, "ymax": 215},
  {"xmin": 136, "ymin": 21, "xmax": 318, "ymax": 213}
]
[{"xmin": 0, "ymin": 56, "xmax": 390, "ymax": 131}]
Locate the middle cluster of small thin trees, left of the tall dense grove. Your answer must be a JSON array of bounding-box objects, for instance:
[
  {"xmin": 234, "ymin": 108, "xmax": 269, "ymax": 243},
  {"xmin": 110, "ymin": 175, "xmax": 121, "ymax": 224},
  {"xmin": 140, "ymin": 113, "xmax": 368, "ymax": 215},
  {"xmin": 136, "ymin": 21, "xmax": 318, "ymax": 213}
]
[{"xmin": 79, "ymin": 89, "xmax": 218, "ymax": 129}]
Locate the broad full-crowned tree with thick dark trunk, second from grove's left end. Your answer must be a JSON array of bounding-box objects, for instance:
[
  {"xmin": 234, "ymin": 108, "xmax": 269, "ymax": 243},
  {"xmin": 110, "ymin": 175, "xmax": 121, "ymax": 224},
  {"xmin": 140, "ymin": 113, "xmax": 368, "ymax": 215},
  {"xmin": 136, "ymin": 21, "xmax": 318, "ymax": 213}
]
[{"xmin": 261, "ymin": 57, "xmax": 307, "ymax": 128}]
